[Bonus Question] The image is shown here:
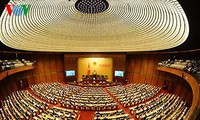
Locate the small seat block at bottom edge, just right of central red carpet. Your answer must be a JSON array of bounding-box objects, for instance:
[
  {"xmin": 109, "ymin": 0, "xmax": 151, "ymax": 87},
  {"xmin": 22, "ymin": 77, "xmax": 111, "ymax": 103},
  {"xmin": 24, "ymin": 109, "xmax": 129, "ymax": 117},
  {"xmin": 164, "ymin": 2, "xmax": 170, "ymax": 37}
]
[{"xmin": 94, "ymin": 109, "xmax": 130, "ymax": 120}]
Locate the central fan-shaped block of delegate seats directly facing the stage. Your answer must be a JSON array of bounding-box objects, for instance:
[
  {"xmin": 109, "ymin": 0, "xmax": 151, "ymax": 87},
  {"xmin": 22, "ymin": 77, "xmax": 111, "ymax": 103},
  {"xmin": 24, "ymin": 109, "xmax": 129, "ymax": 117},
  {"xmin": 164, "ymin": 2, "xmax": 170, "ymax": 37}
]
[{"xmin": 61, "ymin": 87, "xmax": 118, "ymax": 110}]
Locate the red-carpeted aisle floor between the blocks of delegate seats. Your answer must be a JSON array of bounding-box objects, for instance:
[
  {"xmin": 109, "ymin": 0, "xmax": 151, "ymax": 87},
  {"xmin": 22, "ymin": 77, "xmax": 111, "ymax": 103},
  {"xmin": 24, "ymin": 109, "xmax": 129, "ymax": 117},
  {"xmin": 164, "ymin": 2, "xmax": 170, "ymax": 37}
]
[{"xmin": 26, "ymin": 84, "xmax": 169, "ymax": 120}]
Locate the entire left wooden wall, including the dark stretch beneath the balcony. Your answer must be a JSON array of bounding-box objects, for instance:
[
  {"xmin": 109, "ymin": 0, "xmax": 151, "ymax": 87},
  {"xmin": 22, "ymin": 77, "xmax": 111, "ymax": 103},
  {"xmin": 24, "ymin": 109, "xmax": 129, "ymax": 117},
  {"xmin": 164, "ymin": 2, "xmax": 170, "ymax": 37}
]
[{"xmin": 0, "ymin": 53, "xmax": 64, "ymax": 100}]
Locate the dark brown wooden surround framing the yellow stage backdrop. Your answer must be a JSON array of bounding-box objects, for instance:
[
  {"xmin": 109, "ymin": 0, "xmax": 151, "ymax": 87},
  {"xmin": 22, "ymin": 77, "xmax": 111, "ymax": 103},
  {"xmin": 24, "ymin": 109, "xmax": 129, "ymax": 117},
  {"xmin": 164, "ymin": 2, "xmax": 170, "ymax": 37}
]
[{"xmin": 64, "ymin": 53, "xmax": 126, "ymax": 82}]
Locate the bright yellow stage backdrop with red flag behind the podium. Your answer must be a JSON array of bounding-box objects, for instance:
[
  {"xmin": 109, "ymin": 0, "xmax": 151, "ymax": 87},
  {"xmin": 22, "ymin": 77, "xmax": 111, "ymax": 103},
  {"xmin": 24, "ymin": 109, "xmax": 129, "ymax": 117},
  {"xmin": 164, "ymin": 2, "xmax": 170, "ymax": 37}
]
[{"xmin": 78, "ymin": 58, "xmax": 113, "ymax": 82}]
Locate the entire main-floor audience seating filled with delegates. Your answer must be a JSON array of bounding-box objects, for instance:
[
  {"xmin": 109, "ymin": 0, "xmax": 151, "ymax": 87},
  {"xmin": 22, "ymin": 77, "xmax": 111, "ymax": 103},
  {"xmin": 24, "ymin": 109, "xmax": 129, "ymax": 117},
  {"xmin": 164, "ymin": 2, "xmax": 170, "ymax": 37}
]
[{"xmin": 0, "ymin": 83, "xmax": 189, "ymax": 120}]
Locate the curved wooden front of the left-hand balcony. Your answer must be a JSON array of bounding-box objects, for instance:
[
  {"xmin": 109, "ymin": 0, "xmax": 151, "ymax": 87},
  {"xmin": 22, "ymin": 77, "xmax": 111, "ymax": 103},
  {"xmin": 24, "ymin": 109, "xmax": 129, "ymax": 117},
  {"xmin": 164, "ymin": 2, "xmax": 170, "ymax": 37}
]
[{"xmin": 0, "ymin": 66, "xmax": 35, "ymax": 81}]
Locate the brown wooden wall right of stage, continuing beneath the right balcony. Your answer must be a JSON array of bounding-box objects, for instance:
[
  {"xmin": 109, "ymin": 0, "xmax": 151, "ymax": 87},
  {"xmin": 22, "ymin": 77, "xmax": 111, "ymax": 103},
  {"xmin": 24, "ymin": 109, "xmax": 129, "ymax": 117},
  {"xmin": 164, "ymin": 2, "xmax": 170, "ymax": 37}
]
[{"xmin": 126, "ymin": 54, "xmax": 193, "ymax": 106}]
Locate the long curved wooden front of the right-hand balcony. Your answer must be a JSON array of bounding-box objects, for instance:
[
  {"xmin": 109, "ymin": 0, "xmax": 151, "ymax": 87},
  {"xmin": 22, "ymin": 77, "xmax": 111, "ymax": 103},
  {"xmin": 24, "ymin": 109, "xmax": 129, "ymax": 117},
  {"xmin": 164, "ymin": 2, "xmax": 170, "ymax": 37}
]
[{"xmin": 157, "ymin": 66, "xmax": 200, "ymax": 120}]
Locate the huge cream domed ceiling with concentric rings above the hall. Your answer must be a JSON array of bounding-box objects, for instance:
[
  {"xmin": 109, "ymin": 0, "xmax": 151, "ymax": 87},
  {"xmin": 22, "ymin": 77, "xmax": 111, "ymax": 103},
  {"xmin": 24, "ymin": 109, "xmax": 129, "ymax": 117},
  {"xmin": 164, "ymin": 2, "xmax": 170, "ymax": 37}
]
[{"xmin": 0, "ymin": 0, "xmax": 189, "ymax": 52}]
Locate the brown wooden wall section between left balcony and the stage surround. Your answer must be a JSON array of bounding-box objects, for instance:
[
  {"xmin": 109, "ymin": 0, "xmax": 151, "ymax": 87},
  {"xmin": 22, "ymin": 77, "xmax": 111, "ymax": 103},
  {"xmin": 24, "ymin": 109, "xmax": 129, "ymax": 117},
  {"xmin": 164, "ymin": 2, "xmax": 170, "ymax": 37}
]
[{"xmin": 23, "ymin": 54, "xmax": 64, "ymax": 84}]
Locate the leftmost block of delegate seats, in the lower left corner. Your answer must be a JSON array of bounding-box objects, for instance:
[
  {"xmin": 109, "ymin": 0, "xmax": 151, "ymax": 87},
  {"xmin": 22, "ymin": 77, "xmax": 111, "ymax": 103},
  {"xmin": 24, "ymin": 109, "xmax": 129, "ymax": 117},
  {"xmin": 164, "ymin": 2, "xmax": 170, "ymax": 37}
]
[{"xmin": 1, "ymin": 90, "xmax": 49, "ymax": 120}]
